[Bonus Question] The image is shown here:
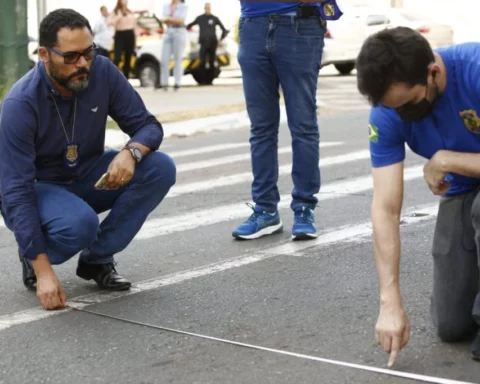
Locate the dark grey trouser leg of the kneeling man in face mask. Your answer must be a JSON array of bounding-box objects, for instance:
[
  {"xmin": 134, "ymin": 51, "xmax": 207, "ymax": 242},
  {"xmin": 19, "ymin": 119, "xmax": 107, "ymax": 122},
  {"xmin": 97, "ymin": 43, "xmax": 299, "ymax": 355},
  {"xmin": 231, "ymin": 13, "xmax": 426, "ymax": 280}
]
[{"xmin": 431, "ymin": 188, "xmax": 480, "ymax": 342}]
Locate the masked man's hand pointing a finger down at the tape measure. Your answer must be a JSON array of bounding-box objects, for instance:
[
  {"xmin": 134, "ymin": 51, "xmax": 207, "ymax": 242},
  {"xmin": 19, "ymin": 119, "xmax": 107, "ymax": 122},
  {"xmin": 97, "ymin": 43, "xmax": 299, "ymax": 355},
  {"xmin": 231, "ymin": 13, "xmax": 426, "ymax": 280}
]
[{"xmin": 375, "ymin": 304, "xmax": 410, "ymax": 367}]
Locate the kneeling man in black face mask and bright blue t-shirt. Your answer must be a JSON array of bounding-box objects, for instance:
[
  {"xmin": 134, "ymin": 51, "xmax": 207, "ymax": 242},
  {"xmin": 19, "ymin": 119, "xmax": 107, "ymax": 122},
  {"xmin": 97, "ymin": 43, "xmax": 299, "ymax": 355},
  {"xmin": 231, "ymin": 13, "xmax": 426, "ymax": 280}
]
[{"xmin": 357, "ymin": 27, "xmax": 480, "ymax": 365}]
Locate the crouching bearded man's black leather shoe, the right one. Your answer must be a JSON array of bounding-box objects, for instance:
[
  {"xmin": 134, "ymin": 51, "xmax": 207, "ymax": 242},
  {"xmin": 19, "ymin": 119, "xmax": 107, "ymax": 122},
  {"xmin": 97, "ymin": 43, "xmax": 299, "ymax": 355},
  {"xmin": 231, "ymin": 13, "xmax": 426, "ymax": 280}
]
[{"xmin": 77, "ymin": 261, "xmax": 132, "ymax": 291}]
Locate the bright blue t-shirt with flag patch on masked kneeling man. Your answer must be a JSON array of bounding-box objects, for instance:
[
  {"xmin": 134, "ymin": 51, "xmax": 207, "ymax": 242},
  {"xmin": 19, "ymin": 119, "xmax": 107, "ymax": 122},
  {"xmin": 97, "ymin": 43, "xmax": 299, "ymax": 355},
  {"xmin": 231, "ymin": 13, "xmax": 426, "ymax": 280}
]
[{"xmin": 369, "ymin": 43, "xmax": 480, "ymax": 196}]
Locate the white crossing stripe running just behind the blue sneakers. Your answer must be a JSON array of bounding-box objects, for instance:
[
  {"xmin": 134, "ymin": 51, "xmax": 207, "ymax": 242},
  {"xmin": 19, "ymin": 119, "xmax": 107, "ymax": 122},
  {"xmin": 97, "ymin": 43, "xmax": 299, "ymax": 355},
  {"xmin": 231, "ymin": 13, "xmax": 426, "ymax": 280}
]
[{"xmin": 134, "ymin": 165, "xmax": 423, "ymax": 241}]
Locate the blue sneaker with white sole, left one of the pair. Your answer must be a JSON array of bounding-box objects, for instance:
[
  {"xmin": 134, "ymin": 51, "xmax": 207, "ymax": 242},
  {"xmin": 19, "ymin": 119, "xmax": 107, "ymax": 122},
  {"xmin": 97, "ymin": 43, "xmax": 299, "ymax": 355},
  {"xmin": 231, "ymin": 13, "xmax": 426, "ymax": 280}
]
[{"xmin": 232, "ymin": 204, "xmax": 283, "ymax": 240}]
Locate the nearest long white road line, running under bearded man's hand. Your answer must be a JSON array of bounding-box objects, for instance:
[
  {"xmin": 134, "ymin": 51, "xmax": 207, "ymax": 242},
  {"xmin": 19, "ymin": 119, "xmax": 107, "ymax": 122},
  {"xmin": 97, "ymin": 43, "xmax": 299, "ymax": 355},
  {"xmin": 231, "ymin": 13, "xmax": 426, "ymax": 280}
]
[{"xmin": 0, "ymin": 202, "xmax": 434, "ymax": 331}]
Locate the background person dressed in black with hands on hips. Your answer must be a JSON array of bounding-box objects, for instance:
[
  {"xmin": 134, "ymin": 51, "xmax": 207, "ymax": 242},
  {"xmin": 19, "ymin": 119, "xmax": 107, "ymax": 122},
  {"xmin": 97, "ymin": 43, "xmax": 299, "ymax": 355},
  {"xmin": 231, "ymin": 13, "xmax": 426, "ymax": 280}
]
[{"xmin": 187, "ymin": 3, "xmax": 229, "ymax": 85}]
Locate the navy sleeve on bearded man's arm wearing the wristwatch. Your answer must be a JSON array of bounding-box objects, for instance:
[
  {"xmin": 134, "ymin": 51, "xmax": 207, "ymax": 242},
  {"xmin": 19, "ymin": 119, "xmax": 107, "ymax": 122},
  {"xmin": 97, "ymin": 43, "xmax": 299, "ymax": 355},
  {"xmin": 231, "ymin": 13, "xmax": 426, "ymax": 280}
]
[{"xmin": 106, "ymin": 61, "xmax": 164, "ymax": 151}]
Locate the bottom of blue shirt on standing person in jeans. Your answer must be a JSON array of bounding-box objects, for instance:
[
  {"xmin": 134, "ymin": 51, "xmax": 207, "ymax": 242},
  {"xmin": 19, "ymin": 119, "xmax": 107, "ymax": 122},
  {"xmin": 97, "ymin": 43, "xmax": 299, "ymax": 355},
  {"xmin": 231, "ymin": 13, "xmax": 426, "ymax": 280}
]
[{"xmin": 240, "ymin": 0, "xmax": 343, "ymax": 20}]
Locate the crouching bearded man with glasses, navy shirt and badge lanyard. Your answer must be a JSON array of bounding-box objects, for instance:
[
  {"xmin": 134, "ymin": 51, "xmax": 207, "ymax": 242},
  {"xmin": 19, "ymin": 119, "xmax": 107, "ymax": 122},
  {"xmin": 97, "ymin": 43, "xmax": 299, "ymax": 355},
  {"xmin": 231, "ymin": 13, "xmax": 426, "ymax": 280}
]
[{"xmin": 0, "ymin": 9, "xmax": 176, "ymax": 309}]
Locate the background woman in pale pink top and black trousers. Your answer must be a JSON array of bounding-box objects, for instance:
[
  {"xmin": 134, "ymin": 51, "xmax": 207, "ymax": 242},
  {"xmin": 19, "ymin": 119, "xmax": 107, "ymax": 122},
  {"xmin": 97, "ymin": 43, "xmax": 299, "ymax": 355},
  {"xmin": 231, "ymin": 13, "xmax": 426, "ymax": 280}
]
[{"xmin": 108, "ymin": 0, "xmax": 137, "ymax": 79}]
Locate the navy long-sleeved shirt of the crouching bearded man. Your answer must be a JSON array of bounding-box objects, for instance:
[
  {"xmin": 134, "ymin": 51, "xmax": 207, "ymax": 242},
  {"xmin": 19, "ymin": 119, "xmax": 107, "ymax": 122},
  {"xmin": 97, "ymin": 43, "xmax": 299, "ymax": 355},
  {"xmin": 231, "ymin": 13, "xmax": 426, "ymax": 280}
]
[{"xmin": 0, "ymin": 56, "xmax": 163, "ymax": 259}]
